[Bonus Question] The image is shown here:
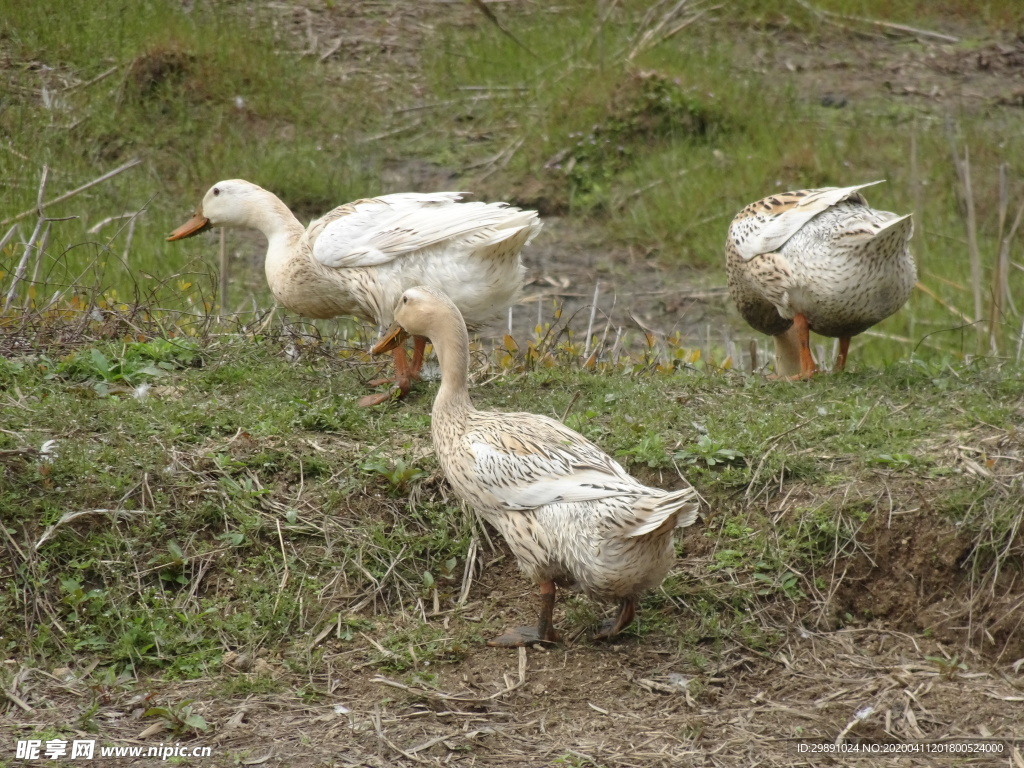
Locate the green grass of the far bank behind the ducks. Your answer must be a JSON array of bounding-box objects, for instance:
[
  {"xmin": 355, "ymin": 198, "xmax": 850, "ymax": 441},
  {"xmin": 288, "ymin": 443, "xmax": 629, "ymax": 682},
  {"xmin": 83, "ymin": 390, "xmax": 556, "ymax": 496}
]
[{"xmin": 0, "ymin": 0, "xmax": 1024, "ymax": 366}]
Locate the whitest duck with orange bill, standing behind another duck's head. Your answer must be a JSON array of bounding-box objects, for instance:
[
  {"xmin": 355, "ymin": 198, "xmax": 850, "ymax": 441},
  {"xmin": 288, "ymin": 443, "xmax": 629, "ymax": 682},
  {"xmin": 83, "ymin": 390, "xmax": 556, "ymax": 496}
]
[{"xmin": 167, "ymin": 179, "xmax": 542, "ymax": 407}]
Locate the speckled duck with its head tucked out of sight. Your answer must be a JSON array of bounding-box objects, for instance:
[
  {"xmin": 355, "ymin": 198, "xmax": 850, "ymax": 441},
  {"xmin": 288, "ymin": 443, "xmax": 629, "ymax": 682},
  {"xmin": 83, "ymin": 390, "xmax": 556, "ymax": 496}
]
[{"xmin": 725, "ymin": 180, "xmax": 918, "ymax": 380}]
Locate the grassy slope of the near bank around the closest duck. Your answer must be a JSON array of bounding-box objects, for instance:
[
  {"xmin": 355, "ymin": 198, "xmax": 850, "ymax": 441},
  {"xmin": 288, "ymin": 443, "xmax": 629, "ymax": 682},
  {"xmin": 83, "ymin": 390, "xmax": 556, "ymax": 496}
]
[{"xmin": 0, "ymin": 337, "xmax": 1024, "ymax": 678}]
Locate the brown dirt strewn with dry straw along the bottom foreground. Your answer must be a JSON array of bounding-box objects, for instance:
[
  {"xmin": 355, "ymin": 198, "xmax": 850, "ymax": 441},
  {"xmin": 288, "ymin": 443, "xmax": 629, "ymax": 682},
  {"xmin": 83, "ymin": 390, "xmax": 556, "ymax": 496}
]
[{"xmin": 9, "ymin": 544, "xmax": 1024, "ymax": 768}]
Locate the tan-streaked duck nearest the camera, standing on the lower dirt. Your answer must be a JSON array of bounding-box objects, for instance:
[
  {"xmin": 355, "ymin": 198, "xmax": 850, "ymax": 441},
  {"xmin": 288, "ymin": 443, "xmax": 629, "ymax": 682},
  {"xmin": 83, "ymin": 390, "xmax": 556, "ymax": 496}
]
[{"xmin": 373, "ymin": 286, "xmax": 698, "ymax": 647}]
